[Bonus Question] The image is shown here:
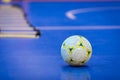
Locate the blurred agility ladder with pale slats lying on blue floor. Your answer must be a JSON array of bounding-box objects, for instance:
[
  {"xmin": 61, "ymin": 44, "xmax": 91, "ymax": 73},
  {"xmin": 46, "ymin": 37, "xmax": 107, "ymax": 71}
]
[{"xmin": 0, "ymin": 5, "xmax": 40, "ymax": 38}]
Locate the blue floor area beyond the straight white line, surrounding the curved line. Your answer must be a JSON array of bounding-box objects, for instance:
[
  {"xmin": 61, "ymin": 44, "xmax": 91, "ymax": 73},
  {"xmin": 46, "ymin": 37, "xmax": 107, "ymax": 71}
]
[{"xmin": 28, "ymin": 2, "xmax": 120, "ymax": 26}]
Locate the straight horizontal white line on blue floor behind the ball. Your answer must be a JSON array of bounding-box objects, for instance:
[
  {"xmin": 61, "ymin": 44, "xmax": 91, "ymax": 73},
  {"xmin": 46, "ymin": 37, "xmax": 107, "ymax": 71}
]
[{"xmin": 36, "ymin": 26, "xmax": 120, "ymax": 30}]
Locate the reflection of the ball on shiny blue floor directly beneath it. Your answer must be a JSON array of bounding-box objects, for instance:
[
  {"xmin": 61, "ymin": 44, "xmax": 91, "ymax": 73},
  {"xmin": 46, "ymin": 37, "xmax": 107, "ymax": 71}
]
[{"xmin": 61, "ymin": 66, "xmax": 91, "ymax": 80}]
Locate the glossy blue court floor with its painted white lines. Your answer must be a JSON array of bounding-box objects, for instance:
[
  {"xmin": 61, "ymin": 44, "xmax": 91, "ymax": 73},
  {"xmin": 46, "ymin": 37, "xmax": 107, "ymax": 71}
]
[{"xmin": 0, "ymin": 2, "xmax": 120, "ymax": 80}]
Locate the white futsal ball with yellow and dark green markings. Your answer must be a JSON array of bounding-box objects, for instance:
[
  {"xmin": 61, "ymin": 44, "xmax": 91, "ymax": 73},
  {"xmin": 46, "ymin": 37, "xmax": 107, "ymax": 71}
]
[{"xmin": 61, "ymin": 35, "xmax": 92, "ymax": 66}]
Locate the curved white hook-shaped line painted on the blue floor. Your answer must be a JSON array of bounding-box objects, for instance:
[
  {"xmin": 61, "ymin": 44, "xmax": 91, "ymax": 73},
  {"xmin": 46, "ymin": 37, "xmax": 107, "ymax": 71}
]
[{"xmin": 65, "ymin": 7, "xmax": 120, "ymax": 20}]
